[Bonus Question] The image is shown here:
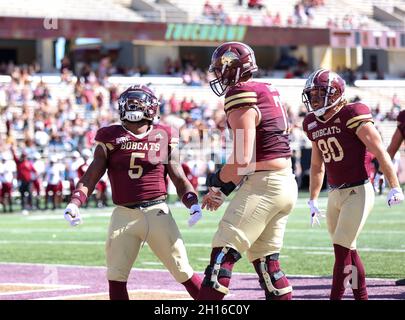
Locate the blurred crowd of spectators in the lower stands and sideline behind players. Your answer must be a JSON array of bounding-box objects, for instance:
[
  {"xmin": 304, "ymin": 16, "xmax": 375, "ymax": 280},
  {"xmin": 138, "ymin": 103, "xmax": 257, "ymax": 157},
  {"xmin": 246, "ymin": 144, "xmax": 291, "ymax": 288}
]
[{"xmin": 0, "ymin": 56, "xmax": 402, "ymax": 211}]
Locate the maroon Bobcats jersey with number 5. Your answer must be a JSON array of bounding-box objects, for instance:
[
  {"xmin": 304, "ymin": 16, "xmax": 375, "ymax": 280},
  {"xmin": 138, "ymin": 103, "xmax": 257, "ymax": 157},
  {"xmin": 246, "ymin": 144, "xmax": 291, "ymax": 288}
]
[{"xmin": 95, "ymin": 125, "xmax": 178, "ymax": 205}]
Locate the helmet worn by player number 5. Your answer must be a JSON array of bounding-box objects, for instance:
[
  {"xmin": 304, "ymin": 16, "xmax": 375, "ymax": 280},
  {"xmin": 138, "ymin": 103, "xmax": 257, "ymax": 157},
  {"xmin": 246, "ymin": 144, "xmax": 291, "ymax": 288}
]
[{"xmin": 118, "ymin": 85, "xmax": 159, "ymax": 122}]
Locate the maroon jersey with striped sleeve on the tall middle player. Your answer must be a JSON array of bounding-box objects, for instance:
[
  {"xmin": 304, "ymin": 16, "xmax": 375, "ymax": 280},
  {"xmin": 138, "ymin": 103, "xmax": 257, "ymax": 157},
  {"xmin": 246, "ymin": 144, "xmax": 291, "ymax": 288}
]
[{"xmin": 225, "ymin": 81, "xmax": 291, "ymax": 162}]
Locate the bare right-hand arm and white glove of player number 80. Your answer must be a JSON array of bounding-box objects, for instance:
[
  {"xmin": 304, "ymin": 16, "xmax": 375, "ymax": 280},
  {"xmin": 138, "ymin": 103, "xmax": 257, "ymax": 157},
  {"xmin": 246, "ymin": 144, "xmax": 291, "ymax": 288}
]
[{"xmin": 356, "ymin": 122, "xmax": 404, "ymax": 206}]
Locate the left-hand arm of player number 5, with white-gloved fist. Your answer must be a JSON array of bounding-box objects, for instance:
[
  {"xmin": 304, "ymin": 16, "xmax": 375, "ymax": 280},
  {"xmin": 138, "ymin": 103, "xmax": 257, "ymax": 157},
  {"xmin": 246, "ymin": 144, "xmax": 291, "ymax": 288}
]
[{"xmin": 64, "ymin": 145, "xmax": 107, "ymax": 226}]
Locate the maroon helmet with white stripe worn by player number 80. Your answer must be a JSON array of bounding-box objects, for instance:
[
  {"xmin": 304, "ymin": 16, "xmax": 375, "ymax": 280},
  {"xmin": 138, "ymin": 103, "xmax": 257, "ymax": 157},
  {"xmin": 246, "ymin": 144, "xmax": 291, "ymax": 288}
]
[{"xmin": 302, "ymin": 69, "xmax": 346, "ymax": 117}]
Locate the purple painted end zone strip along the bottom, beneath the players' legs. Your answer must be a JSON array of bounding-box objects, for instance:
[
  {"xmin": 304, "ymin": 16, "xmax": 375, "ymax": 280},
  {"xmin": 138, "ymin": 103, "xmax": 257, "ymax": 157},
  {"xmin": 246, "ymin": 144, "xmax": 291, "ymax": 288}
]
[{"xmin": 0, "ymin": 263, "xmax": 405, "ymax": 300}]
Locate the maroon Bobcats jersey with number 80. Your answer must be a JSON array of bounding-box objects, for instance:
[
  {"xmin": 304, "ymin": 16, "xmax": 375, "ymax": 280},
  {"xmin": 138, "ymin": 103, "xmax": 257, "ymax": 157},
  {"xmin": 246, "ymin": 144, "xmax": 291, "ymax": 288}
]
[{"xmin": 302, "ymin": 103, "xmax": 373, "ymax": 187}]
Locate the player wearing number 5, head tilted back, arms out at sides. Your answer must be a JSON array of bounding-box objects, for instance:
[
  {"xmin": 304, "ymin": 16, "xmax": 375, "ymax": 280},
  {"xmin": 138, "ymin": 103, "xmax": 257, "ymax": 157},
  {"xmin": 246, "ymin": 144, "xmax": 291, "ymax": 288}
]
[{"xmin": 64, "ymin": 86, "xmax": 201, "ymax": 300}]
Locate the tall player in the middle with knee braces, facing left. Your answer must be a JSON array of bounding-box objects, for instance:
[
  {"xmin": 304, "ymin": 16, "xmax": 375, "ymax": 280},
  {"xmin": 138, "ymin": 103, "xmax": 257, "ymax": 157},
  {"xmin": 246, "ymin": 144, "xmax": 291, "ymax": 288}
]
[{"xmin": 199, "ymin": 42, "xmax": 298, "ymax": 300}]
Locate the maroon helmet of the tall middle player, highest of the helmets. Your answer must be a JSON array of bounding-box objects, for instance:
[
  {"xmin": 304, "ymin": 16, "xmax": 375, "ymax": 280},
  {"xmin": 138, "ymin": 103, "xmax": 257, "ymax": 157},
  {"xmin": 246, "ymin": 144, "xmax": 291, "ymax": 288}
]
[{"xmin": 208, "ymin": 42, "xmax": 258, "ymax": 96}]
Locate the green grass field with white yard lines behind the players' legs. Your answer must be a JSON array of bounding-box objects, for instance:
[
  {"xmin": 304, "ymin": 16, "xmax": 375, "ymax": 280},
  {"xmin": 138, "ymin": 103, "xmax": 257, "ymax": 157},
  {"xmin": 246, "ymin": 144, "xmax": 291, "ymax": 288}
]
[{"xmin": 0, "ymin": 196, "xmax": 405, "ymax": 278}]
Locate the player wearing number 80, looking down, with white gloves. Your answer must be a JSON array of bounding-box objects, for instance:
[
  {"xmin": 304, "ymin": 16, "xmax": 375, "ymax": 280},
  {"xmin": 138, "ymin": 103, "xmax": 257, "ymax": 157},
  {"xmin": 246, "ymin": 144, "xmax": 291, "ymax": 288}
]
[{"xmin": 302, "ymin": 69, "xmax": 404, "ymax": 300}]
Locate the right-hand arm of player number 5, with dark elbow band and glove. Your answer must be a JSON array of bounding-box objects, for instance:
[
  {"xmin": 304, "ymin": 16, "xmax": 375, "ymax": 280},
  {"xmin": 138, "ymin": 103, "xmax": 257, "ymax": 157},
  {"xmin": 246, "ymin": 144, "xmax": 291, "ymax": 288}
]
[{"xmin": 167, "ymin": 148, "xmax": 202, "ymax": 227}]
